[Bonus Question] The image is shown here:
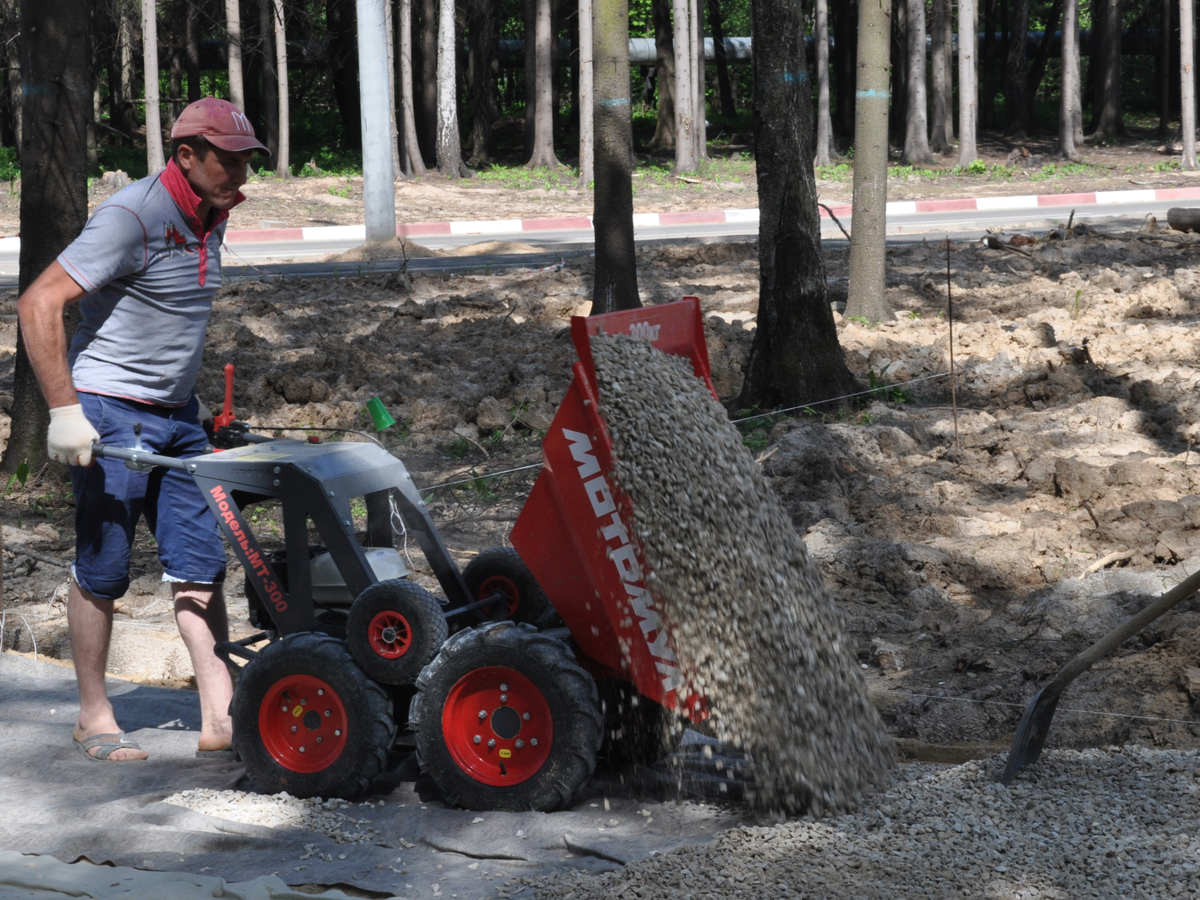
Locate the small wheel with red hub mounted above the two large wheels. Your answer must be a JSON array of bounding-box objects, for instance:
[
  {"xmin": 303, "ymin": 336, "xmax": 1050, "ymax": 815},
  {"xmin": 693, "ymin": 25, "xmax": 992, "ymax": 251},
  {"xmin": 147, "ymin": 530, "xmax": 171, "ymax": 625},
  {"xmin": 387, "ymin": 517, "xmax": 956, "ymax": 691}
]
[{"xmin": 346, "ymin": 578, "xmax": 446, "ymax": 684}]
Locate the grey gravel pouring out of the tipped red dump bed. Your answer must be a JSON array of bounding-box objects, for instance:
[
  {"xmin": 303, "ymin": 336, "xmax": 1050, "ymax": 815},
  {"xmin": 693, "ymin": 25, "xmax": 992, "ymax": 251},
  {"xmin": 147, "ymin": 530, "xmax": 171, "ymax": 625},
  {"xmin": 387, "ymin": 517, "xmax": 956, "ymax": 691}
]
[{"xmin": 592, "ymin": 335, "xmax": 892, "ymax": 815}]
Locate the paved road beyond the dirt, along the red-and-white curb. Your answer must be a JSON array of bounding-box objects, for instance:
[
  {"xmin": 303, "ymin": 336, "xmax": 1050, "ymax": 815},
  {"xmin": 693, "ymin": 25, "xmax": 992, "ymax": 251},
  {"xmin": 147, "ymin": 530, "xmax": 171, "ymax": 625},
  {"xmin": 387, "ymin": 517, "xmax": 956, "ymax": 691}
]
[{"xmin": 0, "ymin": 202, "xmax": 1174, "ymax": 288}]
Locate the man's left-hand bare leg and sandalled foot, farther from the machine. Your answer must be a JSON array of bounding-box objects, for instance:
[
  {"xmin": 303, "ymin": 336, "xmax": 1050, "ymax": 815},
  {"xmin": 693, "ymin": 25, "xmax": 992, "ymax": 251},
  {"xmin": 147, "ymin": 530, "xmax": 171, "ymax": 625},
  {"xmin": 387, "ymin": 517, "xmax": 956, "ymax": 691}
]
[{"xmin": 67, "ymin": 581, "xmax": 148, "ymax": 762}]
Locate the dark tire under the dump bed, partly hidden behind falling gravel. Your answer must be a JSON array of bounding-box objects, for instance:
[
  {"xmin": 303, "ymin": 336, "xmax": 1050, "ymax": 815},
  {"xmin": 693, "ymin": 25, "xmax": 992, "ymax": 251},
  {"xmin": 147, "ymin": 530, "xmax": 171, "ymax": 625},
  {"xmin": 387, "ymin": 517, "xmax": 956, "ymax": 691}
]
[{"xmin": 596, "ymin": 678, "xmax": 688, "ymax": 768}]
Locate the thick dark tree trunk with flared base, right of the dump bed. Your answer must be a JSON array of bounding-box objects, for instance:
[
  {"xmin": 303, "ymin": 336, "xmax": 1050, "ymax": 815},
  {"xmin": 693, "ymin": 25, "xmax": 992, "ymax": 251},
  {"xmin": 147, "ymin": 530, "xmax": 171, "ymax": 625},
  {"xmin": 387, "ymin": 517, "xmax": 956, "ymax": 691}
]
[{"xmin": 738, "ymin": 0, "xmax": 859, "ymax": 408}]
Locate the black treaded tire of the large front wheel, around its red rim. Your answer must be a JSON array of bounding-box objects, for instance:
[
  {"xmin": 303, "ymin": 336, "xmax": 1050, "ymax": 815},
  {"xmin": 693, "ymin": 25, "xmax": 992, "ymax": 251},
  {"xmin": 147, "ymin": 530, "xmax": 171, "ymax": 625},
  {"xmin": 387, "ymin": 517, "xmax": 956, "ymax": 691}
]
[{"xmin": 408, "ymin": 622, "xmax": 604, "ymax": 812}]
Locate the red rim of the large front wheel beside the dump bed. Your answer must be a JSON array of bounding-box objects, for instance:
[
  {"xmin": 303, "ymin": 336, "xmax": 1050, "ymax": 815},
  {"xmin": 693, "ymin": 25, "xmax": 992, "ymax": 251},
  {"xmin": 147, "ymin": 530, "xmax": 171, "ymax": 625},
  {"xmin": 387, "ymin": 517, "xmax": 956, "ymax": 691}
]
[{"xmin": 442, "ymin": 666, "xmax": 554, "ymax": 787}]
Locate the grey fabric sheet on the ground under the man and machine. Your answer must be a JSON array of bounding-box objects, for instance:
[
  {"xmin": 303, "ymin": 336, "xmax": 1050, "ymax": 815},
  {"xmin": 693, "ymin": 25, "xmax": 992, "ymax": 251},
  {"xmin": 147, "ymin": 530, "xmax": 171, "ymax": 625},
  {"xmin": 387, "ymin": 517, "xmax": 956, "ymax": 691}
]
[{"xmin": 0, "ymin": 654, "xmax": 746, "ymax": 898}]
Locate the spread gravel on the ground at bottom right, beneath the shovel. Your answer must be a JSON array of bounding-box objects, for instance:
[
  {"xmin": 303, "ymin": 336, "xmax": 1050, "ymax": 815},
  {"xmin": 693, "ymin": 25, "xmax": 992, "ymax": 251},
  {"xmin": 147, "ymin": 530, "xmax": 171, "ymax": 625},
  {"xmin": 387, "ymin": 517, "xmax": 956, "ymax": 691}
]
[{"xmin": 535, "ymin": 748, "xmax": 1200, "ymax": 900}]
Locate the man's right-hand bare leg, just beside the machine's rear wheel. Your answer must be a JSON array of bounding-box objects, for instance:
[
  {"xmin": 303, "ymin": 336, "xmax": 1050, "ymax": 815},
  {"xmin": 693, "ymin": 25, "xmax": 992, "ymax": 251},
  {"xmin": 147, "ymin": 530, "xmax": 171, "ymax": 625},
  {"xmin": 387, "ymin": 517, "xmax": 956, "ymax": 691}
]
[{"xmin": 172, "ymin": 583, "xmax": 233, "ymax": 750}]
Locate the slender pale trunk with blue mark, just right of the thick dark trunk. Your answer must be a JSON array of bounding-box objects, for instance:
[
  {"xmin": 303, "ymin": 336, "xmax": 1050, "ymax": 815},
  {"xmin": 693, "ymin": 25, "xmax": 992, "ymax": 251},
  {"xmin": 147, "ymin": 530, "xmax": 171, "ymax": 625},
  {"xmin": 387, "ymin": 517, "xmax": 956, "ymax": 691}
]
[{"xmin": 844, "ymin": 0, "xmax": 892, "ymax": 323}]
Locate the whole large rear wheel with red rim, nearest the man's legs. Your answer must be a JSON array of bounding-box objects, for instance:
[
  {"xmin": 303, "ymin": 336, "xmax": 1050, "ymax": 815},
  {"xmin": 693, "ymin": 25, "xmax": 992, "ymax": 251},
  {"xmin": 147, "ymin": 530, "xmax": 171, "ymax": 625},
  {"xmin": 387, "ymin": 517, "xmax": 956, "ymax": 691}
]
[{"xmin": 230, "ymin": 631, "xmax": 396, "ymax": 797}]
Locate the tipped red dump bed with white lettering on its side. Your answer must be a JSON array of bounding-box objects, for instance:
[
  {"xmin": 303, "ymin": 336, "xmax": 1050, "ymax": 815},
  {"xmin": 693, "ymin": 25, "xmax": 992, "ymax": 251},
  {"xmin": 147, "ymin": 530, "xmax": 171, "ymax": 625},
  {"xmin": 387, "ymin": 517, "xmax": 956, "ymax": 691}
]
[{"xmin": 512, "ymin": 296, "xmax": 716, "ymax": 719}]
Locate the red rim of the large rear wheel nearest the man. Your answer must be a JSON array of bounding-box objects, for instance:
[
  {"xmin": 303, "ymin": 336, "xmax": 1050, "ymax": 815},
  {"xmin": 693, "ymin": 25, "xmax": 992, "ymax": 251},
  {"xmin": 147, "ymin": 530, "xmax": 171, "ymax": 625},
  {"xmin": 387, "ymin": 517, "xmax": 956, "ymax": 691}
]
[{"xmin": 258, "ymin": 674, "xmax": 348, "ymax": 772}]
